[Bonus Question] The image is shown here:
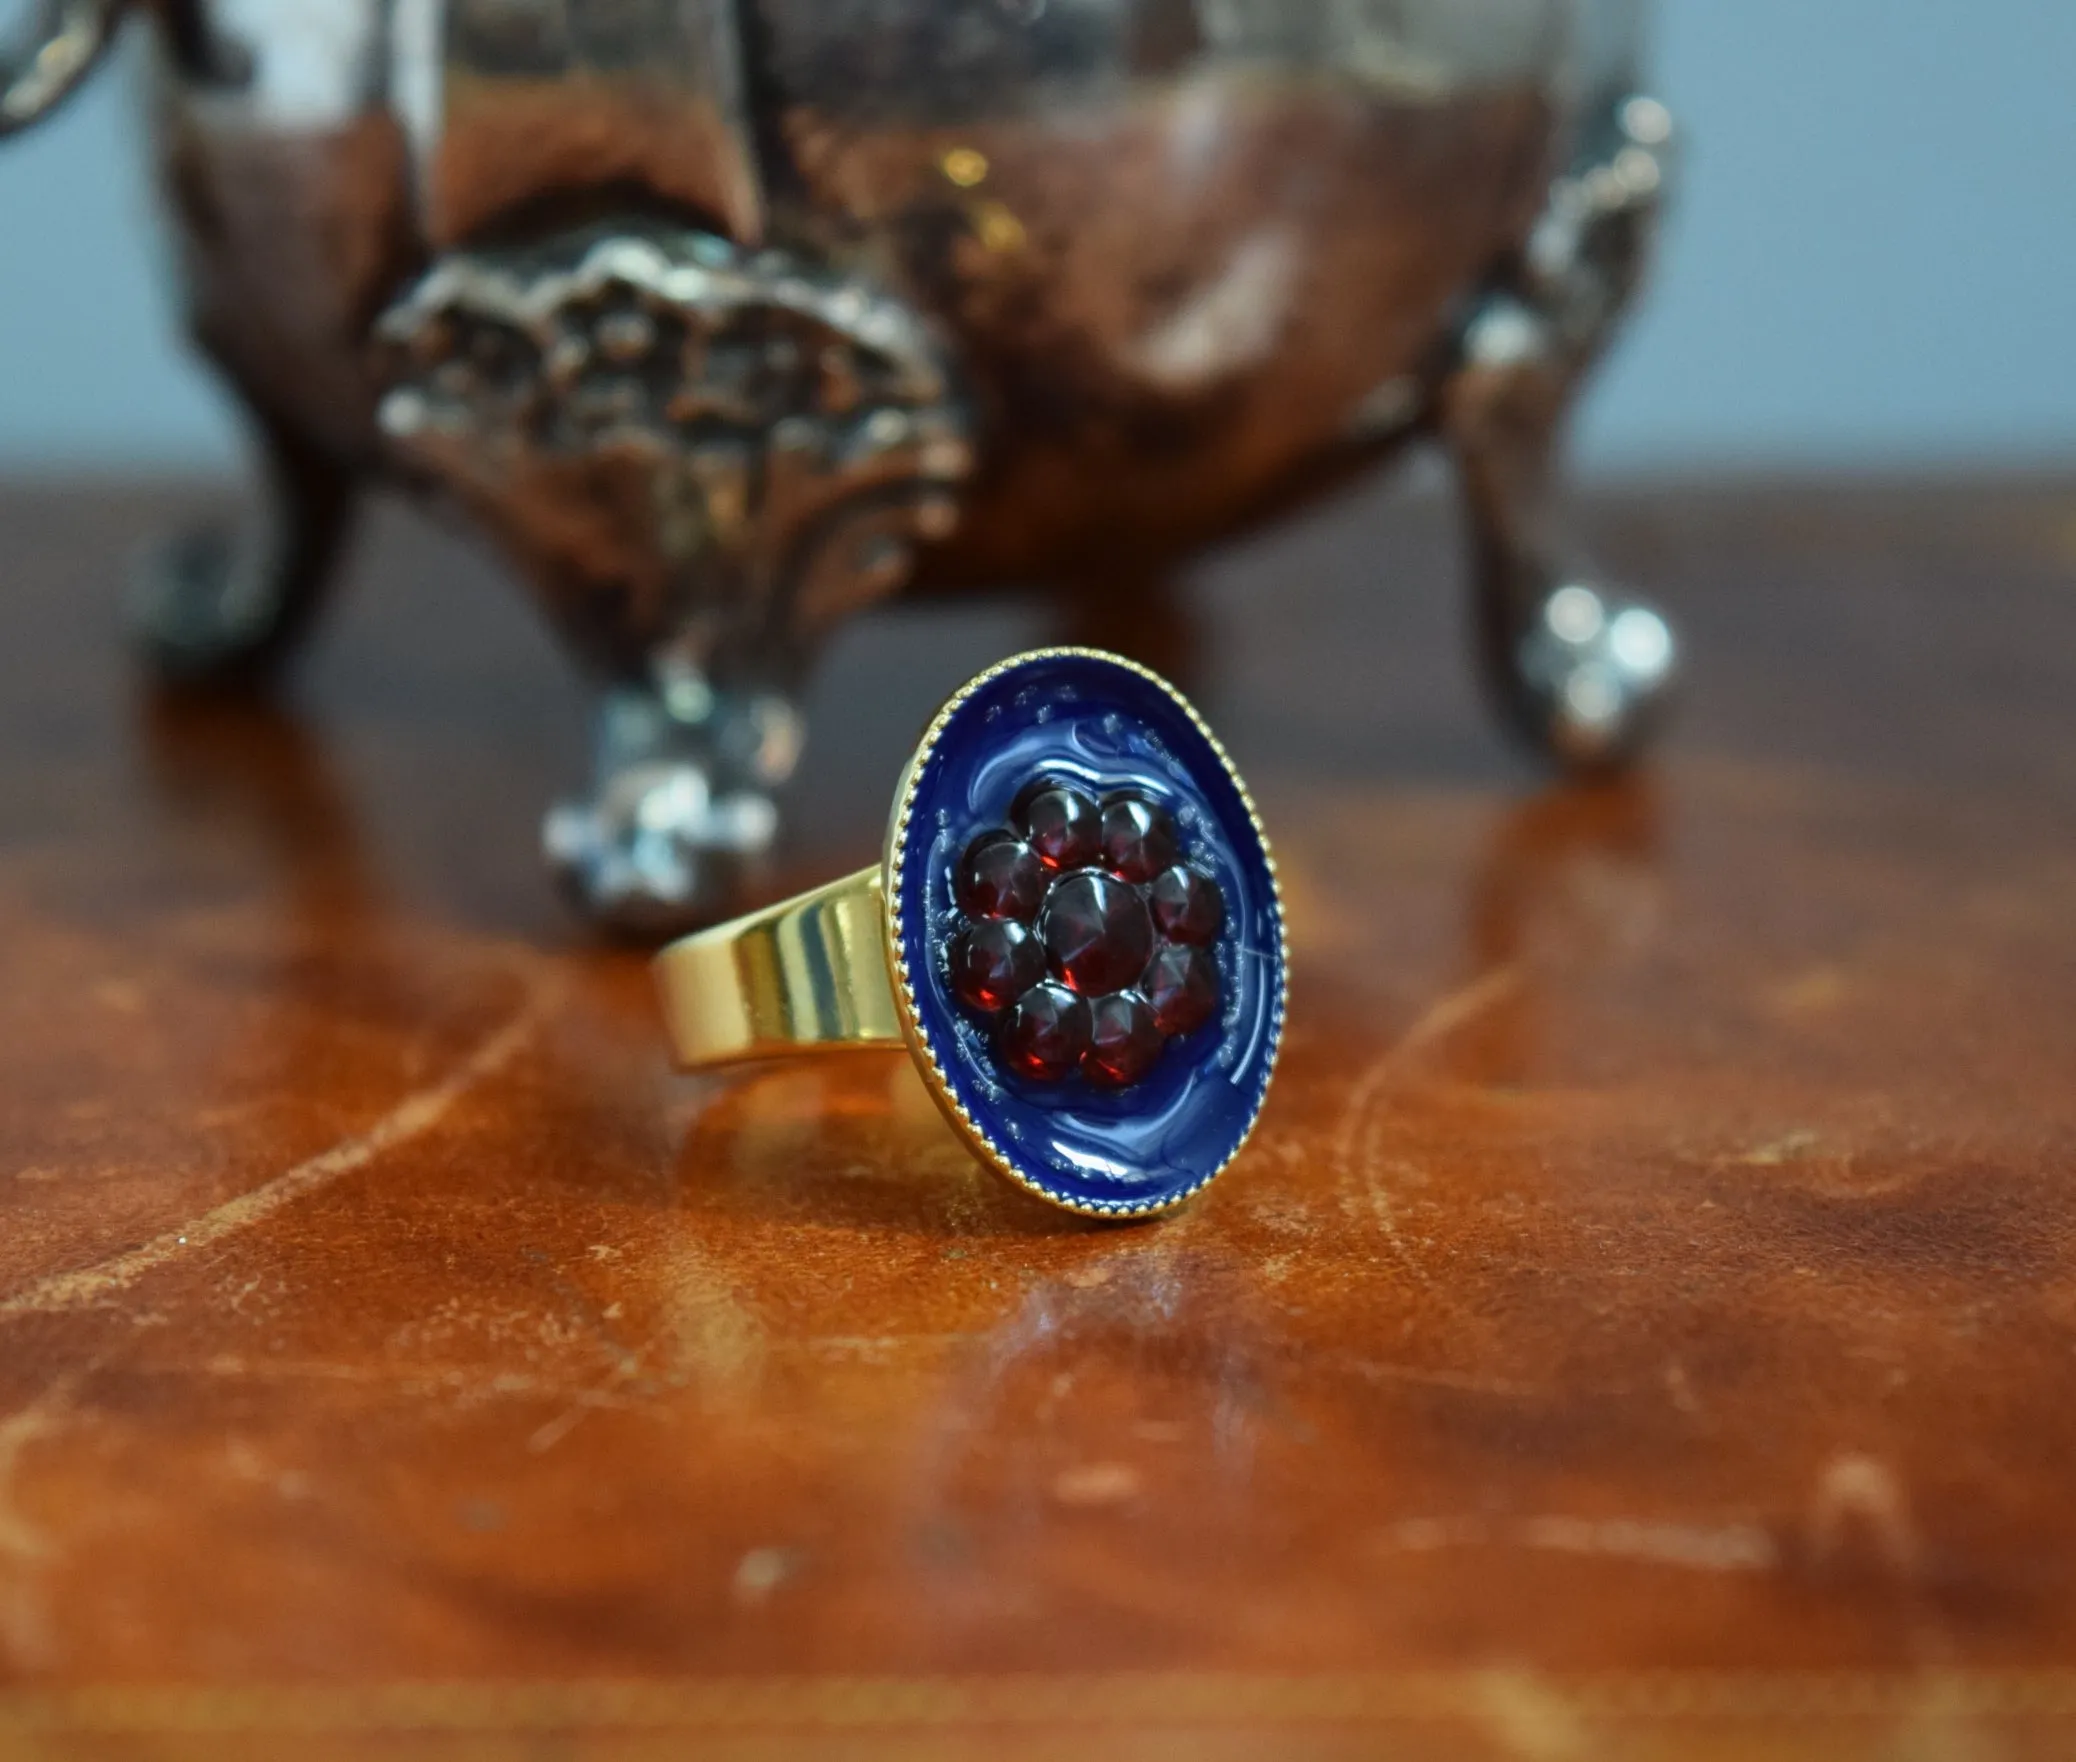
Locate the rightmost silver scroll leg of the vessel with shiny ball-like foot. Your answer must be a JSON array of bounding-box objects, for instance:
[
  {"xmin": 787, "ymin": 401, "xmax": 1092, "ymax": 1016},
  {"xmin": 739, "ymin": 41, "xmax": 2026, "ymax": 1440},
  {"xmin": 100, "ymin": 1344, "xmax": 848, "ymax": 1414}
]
[{"xmin": 1439, "ymin": 98, "xmax": 1677, "ymax": 768}]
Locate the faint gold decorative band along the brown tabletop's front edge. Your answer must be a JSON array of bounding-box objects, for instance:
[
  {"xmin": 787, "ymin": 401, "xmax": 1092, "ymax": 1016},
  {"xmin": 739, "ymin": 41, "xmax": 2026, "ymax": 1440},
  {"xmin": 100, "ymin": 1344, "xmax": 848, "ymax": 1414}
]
[{"xmin": 0, "ymin": 1667, "xmax": 2076, "ymax": 1754}]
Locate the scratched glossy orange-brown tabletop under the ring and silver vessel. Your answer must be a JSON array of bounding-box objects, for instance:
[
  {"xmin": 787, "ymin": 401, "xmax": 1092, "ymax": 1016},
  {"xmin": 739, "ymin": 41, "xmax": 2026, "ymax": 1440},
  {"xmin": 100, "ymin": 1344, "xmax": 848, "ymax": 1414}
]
[{"xmin": 0, "ymin": 481, "xmax": 2076, "ymax": 1762}]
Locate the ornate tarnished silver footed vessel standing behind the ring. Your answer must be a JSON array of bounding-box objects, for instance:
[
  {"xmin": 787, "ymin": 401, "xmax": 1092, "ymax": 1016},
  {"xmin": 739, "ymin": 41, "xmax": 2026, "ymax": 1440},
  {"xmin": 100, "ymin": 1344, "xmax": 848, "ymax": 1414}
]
[{"xmin": 0, "ymin": 0, "xmax": 1673, "ymax": 934}]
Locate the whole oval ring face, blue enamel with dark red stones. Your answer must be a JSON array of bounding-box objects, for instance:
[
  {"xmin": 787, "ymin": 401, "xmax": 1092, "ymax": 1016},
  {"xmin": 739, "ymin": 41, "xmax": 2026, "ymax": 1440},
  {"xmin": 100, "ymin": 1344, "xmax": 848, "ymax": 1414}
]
[{"xmin": 884, "ymin": 650, "xmax": 1285, "ymax": 1216}]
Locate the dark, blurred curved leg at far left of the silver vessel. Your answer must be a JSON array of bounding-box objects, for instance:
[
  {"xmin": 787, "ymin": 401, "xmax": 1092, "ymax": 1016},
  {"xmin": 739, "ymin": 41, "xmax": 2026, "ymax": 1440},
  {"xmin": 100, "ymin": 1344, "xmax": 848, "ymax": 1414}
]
[{"xmin": 129, "ymin": 417, "xmax": 359, "ymax": 689}]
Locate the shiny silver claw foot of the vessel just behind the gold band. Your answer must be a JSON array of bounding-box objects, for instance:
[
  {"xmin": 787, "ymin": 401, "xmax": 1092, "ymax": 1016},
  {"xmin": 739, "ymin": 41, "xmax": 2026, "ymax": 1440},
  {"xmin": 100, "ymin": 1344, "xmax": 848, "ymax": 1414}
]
[{"xmin": 542, "ymin": 681, "xmax": 801, "ymax": 940}]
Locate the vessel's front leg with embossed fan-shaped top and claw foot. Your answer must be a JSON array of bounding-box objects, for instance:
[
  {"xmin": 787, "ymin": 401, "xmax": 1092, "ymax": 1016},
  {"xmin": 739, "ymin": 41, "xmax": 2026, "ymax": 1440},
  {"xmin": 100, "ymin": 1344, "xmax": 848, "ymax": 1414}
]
[{"xmin": 376, "ymin": 228, "xmax": 972, "ymax": 932}]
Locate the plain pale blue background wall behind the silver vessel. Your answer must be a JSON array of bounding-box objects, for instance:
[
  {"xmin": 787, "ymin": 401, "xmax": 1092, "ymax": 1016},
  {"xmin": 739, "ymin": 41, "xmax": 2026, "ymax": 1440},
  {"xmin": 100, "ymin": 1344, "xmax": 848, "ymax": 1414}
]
[{"xmin": 0, "ymin": 0, "xmax": 2076, "ymax": 471}]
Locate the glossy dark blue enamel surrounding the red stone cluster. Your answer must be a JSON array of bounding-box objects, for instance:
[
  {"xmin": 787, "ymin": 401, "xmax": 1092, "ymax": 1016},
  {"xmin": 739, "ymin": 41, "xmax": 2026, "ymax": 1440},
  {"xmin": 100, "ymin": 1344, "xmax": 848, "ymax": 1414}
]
[{"xmin": 889, "ymin": 652, "xmax": 1283, "ymax": 1214}]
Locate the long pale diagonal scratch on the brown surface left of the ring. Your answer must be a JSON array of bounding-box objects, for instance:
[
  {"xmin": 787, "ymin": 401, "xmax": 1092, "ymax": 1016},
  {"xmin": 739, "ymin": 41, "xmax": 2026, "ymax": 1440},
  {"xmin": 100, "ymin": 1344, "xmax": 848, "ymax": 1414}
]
[{"xmin": 0, "ymin": 984, "xmax": 556, "ymax": 1322}]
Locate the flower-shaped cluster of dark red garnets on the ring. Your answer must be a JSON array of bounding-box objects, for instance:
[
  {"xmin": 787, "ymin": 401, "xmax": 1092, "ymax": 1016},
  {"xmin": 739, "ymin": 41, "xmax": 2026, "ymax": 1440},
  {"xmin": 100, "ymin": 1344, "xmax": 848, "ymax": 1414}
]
[{"xmin": 947, "ymin": 782, "xmax": 1225, "ymax": 1090}]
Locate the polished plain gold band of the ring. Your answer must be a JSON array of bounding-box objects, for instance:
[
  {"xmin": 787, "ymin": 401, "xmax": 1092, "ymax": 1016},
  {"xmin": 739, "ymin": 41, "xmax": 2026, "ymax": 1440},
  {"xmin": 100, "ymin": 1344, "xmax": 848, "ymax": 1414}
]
[{"xmin": 656, "ymin": 868, "xmax": 903, "ymax": 1071}]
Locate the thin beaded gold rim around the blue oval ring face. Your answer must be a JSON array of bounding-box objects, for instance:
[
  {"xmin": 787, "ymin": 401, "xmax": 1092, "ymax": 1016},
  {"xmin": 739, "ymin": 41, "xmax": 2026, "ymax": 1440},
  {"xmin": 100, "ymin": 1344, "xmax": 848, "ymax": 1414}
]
[{"xmin": 882, "ymin": 648, "xmax": 1289, "ymax": 1218}]
